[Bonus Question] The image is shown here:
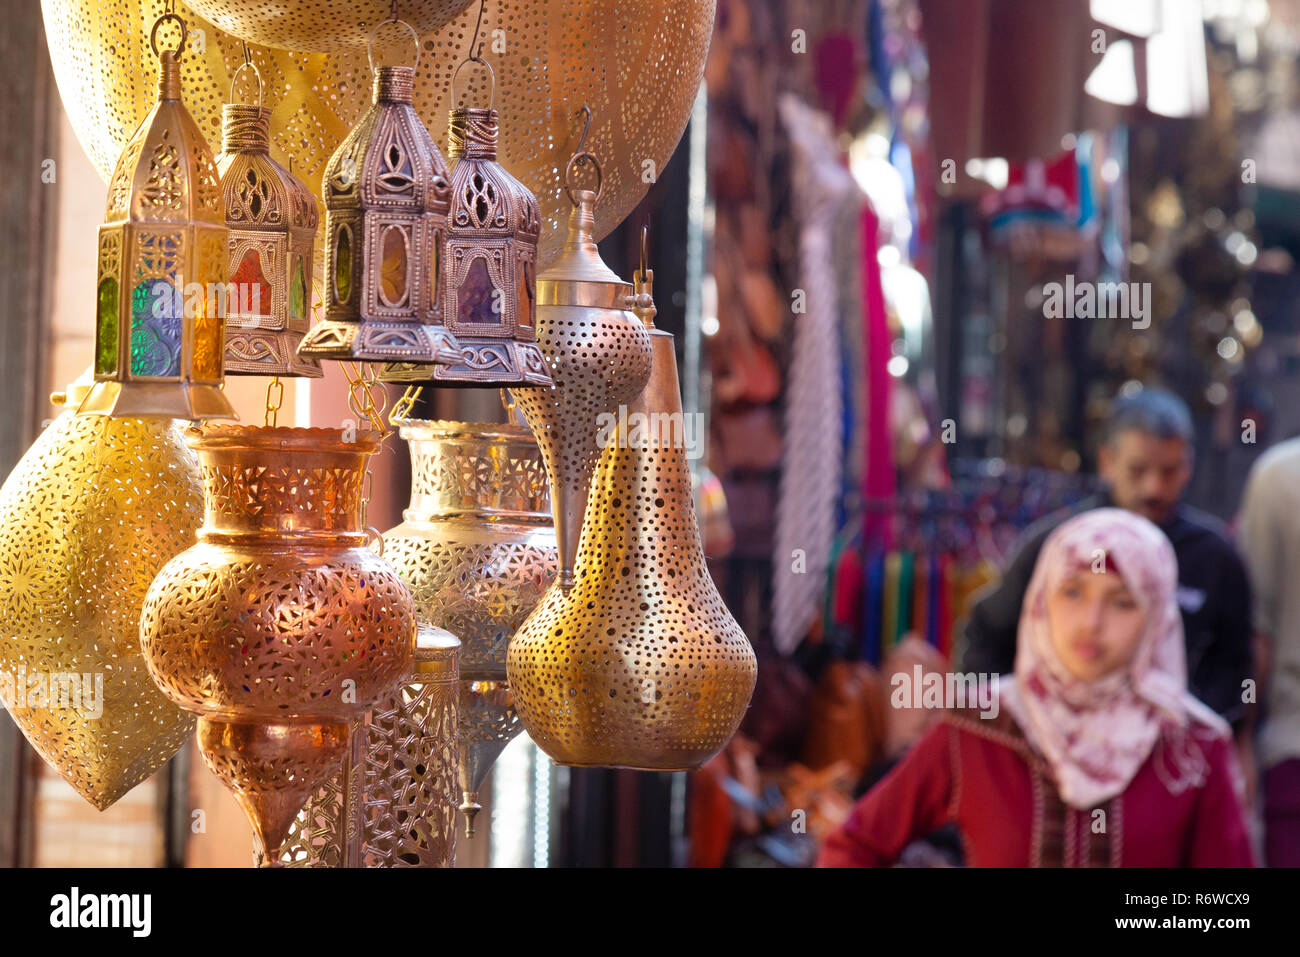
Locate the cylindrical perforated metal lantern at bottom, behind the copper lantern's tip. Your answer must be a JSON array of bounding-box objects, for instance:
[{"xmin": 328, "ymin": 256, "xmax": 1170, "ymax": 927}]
[{"xmin": 271, "ymin": 623, "xmax": 460, "ymax": 867}]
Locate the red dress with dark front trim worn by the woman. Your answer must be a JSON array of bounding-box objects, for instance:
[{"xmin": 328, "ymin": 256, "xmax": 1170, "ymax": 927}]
[{"xmin": 818, "ymin": 711, "xmax": 1255, "ymax": 867}]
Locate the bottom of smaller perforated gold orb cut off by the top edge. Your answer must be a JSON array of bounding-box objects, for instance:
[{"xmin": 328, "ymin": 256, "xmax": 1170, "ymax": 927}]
[{"xmin": 180, "ymin": 0, "xmax": 472, "ymax": 53}]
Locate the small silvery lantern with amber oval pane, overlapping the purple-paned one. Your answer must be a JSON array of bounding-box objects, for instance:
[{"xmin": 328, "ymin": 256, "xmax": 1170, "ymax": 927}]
[{"xmin": 298, "ymin": 20, "xmax": 462, "ymax": 369}]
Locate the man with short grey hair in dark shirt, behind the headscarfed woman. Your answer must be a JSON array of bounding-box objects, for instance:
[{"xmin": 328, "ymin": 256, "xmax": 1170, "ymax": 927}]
[{"xmin": 962, "ymin": 389, "xmax": 1252, "ymax": 724}]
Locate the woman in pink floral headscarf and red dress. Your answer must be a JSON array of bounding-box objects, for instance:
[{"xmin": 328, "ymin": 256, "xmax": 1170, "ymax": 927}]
[{"xmin": 818, "ymin": 508, "xmax": 1255, "ymax": 867}]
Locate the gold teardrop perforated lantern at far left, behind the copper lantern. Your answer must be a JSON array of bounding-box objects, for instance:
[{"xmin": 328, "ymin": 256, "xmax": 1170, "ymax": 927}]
[{"xmin": 0, "ymin": 369, "xmax": 203, "ymax": 810}]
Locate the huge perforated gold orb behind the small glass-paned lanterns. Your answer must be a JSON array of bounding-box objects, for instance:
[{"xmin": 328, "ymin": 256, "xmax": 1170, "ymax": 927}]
[{"xmin": 42, "ymin": 0, "xmax": 715, "ymax": 274}]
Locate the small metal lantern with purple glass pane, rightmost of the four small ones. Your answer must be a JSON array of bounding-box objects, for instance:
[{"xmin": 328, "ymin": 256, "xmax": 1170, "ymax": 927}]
[{"xmin": 380, "ymin": 56, "xmax": 551, "ymax": 386}]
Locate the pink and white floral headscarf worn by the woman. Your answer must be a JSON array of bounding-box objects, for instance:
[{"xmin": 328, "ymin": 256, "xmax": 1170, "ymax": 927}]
[{"xmin": 998, "ymin": 508, "xmax": 1231, "ymax": 809}]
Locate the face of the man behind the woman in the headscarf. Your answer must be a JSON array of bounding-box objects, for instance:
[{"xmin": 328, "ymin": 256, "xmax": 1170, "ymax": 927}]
[{"xmin": 1097, "ymin": 429, "xmax": 1192, "ymax": 525}]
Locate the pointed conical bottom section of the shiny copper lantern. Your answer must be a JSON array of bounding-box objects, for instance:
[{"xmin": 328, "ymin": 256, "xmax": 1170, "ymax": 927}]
[{"xmin": 198, "ymin": 718, "xmax": 348, "ymax": 866}]
